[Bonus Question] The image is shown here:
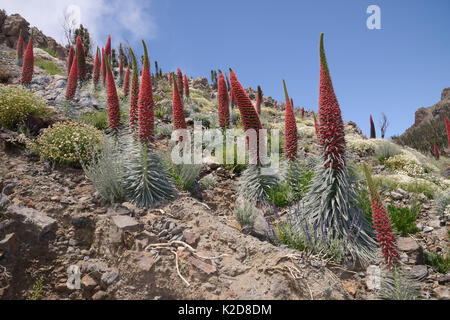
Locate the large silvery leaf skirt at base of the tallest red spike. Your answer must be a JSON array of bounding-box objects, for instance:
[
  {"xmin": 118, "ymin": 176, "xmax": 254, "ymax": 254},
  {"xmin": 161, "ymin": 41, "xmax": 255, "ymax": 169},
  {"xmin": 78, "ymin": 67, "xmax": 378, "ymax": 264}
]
[{"xmin": 293, "ymin": 160, "xmax": 377, "ymax": 265}]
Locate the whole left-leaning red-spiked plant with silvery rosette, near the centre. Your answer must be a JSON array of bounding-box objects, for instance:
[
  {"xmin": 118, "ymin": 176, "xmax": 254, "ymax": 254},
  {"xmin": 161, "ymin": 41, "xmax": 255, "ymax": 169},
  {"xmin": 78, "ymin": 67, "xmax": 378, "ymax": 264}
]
[{"xmin": 230, "ymin": 69, "xmax": 279, "ymax": 206}]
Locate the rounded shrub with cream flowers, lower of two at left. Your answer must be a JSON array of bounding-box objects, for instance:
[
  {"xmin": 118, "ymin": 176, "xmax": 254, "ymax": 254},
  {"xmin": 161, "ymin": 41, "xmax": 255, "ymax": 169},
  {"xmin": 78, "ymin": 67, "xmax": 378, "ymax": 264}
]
[{"xmin": 29, "ymin": 122, "xmax": 103, "ymax": 165}]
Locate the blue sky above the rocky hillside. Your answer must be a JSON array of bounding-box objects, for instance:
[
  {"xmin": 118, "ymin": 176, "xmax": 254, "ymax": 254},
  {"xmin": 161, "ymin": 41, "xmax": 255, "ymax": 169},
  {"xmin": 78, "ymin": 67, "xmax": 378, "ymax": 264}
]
[{"xmin": 0, "ymin": 0, "xmax": 450, "ymax": 137}]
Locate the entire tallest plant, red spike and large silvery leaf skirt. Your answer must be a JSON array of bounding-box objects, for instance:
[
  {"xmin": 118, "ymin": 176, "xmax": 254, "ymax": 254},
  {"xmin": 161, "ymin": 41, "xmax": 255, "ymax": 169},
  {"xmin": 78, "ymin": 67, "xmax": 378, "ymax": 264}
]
[{"xmin": 288, "ymin": 34, "xmax": 376, "ymax": 265}]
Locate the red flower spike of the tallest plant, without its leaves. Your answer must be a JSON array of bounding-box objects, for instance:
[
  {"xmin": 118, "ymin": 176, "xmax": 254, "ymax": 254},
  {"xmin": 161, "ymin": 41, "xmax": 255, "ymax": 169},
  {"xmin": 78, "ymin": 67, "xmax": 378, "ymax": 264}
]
[{"xmin": 319, "ymin": 33, "xmax": 346, "ymax": 171}]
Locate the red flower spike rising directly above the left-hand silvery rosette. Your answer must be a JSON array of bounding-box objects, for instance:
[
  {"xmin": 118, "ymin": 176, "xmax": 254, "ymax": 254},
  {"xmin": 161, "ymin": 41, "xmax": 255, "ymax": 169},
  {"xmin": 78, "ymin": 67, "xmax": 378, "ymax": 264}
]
[{"xmin": 138, "ymin": 40, "xmax": 155, "ymax": 143}]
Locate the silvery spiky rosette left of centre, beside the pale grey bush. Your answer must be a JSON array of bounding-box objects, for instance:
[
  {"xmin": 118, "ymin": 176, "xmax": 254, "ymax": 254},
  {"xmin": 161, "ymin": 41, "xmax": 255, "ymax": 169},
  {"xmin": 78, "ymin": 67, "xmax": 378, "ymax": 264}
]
[{"xmin": 124, "ymin": 139, "xmax": 176, "ymax": 208}]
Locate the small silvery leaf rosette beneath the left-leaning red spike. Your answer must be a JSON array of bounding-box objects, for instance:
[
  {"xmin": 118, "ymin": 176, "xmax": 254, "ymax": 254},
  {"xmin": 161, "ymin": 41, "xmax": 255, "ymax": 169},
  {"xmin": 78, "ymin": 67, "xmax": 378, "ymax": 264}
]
[{"xmin": 239, "ymin": 164, "xmax": 279, "ymax": 206}]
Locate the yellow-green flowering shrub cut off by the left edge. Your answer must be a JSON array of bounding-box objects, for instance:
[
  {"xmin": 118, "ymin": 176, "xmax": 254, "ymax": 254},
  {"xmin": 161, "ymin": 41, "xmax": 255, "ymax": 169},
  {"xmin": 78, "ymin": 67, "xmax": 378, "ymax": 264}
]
[{"xmin": 0, "ymin": 86, "xmax": 51, "ymax": 129}]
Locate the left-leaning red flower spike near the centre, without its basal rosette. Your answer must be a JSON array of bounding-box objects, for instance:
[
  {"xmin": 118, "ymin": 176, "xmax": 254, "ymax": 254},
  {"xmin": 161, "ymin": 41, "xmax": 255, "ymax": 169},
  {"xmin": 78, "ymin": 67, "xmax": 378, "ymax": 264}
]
[{"xmin": 230, "ymin": 69, "xmax": 265, "ymax": 163}]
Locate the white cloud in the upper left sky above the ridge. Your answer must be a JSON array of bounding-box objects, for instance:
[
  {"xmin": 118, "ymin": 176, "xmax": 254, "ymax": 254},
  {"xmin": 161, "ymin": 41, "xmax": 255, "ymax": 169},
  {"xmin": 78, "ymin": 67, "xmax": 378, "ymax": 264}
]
[{"xmin": 0, "ymin": 0, "xmax": 156, "ymax": 46}]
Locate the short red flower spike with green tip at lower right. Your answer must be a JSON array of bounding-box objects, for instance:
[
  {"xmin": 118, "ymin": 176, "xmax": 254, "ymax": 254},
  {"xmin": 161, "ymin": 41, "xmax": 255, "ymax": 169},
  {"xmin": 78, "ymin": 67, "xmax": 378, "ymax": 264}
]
[{"xmin": 364, "ymin": 165, "xmax": 400, "ymax": 269}]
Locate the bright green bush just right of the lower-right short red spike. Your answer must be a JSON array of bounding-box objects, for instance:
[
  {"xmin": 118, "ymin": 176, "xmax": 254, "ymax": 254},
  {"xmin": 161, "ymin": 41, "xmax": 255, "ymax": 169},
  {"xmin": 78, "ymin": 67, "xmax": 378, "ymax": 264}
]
[{"xmin": 388, "ymin": 203, "xmax": 420, "ymax": 236}]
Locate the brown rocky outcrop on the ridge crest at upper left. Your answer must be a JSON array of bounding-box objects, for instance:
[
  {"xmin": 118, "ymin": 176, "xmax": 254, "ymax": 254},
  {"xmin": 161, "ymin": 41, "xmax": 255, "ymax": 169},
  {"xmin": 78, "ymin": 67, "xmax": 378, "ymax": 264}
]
[{"xmin": 0, "ymin": 10, "xmax": 66, "ymax": 59}]
